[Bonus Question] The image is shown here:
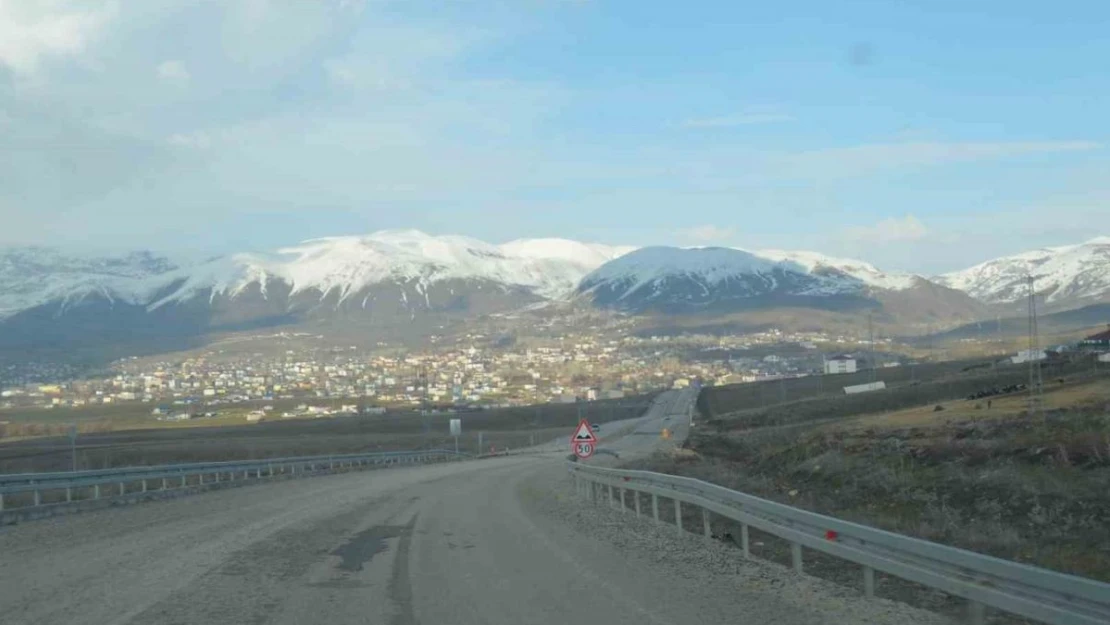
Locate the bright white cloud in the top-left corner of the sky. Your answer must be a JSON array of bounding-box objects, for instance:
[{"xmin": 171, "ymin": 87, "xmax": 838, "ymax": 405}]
[{"xmin": 0, "ymin": 0, "xmax": 115, "ymax": 75}]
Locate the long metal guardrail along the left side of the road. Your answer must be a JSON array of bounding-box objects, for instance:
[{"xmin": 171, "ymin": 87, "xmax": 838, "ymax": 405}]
[{"xmin": 0, "ymin": 450, "xmax": 459, "ymax": 512}]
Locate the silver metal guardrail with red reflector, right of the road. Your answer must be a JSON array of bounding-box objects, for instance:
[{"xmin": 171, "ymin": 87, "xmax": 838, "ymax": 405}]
[{"xmin": 567, "ymin": 463, "xmax": 1110, "ymax": 625}]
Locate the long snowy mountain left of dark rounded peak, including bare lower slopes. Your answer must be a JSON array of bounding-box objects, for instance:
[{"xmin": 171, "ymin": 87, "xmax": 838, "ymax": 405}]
[{"xmin": 0, "ymin": 231, "xmax": 628, "ymax": 349}]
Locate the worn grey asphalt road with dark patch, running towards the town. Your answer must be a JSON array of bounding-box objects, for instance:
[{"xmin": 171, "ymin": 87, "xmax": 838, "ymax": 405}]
[{"xmin": 0, "ymin": 393, "xmax": 945, "ymax": 625}]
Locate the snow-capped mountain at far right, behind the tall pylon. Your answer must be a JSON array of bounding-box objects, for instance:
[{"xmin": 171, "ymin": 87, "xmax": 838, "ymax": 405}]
[{"xmin": 934, "ymin": 236, "xmax": 1110, "ymax": 310}]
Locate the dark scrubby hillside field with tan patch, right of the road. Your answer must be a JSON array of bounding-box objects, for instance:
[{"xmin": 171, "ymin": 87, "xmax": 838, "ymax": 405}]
[{"xmin": 636, "ymin": 360, "xmax": 1110, "ymax": 612}]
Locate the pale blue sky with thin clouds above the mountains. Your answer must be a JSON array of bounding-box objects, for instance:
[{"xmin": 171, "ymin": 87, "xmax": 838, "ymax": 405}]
[{"xmin": 0, "ymin": 0, "xmax": 1110, "ymax": 274}]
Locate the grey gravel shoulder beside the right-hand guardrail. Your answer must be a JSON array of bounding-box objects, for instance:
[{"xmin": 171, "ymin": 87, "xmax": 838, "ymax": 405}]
[{"xmin": 517, "ymin": 464, "xmax": 952, "ymax": 625}]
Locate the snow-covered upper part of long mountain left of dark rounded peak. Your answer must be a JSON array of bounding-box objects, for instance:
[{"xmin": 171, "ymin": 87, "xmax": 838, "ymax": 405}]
[{"xmin": 0, "ymin": 231, "xmax": 632, "ymax": 319}]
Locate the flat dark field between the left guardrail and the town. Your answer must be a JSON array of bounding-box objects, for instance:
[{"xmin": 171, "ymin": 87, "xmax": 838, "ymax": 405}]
[{"xmin": 0, "ymin": 396, "xmax": 650, "ymax": 473}]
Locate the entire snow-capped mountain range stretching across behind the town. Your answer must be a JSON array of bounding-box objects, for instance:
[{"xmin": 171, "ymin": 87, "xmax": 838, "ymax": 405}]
[{"xmin": 0, "ymin": 230, "xmax": 1110, "ymax": 349}]
